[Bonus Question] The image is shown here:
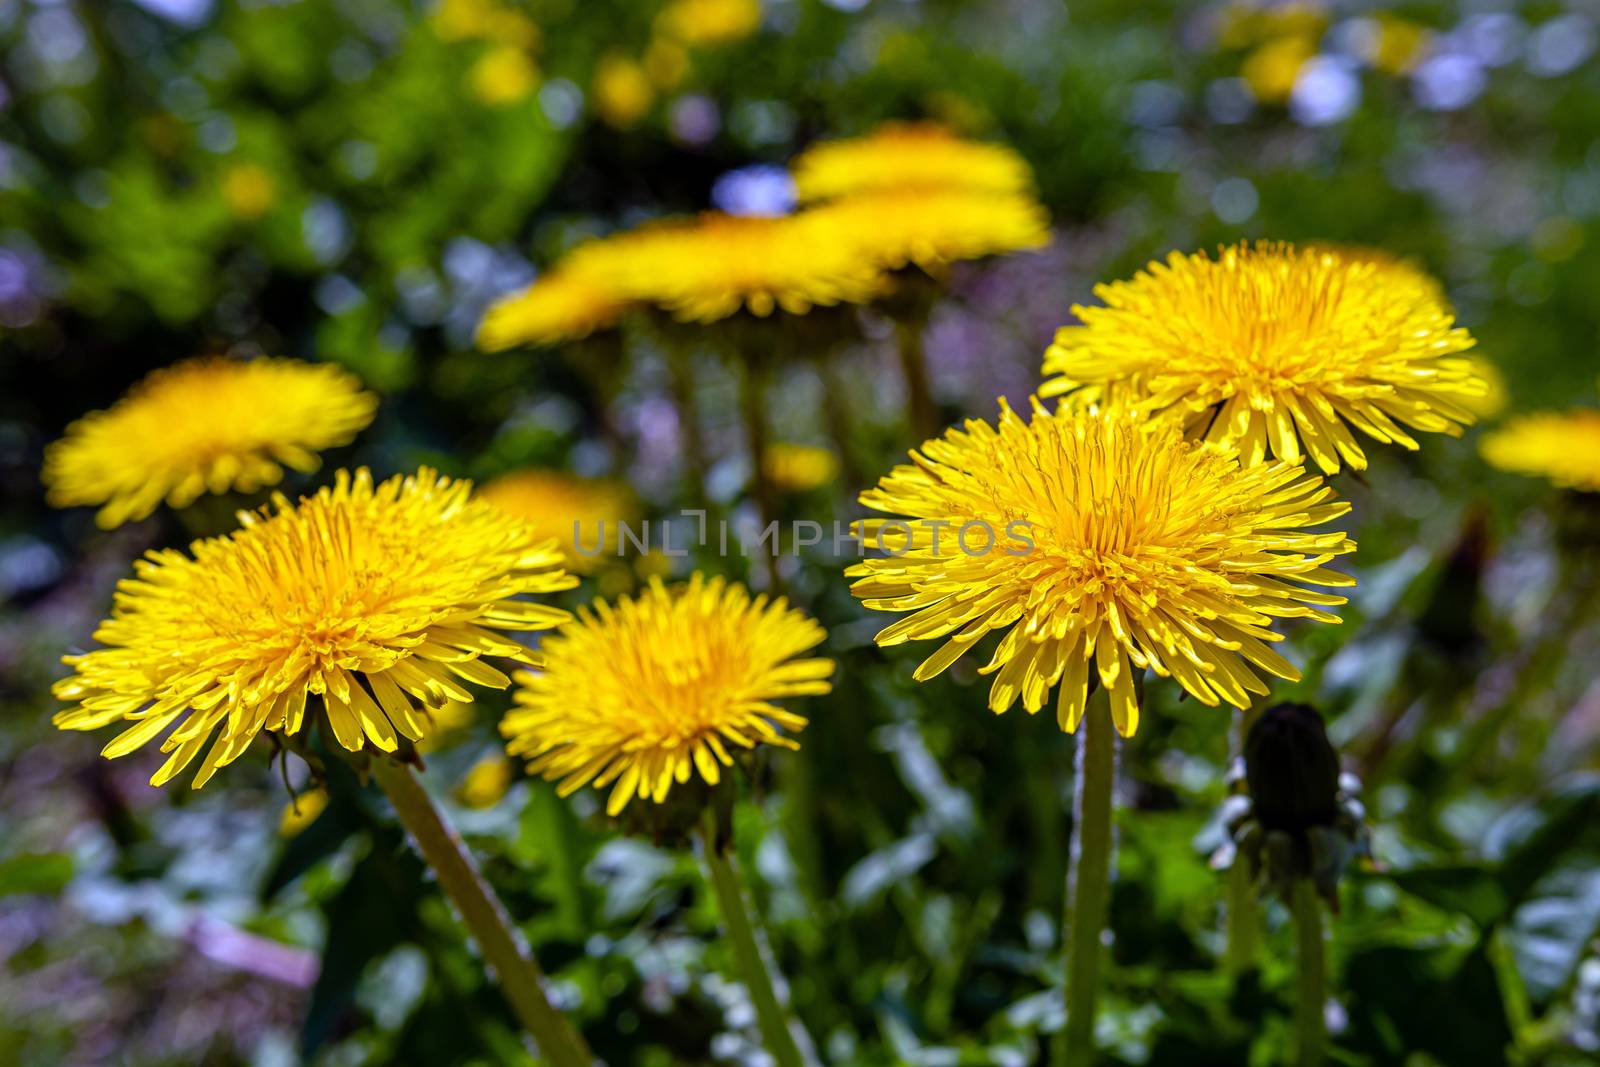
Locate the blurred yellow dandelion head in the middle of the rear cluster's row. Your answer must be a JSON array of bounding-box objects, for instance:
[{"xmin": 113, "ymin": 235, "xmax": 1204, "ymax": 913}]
[{"xmin": 611, "ymin": 213, "xmax": 885, "ymax": 322}]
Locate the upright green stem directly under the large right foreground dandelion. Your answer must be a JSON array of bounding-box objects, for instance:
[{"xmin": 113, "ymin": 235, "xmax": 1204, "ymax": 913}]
[{"xmin": 1056, "ymin": 686, "xmax": 1117, "ymax": 1067}]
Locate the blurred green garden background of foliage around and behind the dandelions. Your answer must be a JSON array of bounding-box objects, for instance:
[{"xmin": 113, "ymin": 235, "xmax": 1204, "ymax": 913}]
[{"xmin": 0, "ymin": 0, "xmax": 1600, "ymax": 1067}]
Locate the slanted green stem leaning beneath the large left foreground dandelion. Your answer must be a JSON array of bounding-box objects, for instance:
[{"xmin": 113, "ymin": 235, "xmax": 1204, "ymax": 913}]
[{"xmin": 371, "ymin": 758, "xmax": 595, "ymax": 1067}]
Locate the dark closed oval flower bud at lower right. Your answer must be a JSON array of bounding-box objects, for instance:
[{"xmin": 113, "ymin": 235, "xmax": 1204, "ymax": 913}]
[{"xmin": 1245, "ymin": 704, "xmax": 1339, "ymax": 833}]
